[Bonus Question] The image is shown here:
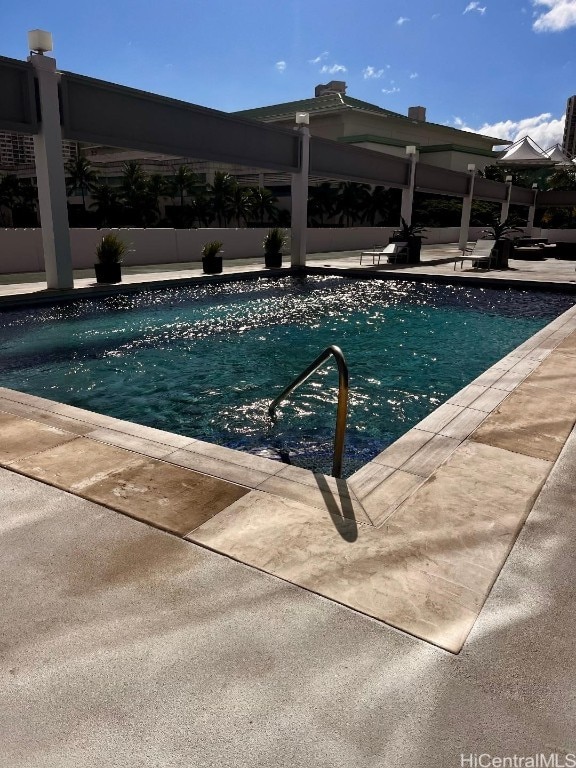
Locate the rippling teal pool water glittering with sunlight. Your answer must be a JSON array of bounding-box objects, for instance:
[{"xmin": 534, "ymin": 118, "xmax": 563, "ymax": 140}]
[{"xmin": 0, "ymin": 277, "xmax": 574, "ymax": 476}]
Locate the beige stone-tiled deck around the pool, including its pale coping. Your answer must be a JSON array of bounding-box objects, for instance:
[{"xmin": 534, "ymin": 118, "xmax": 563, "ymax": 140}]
[{"xmin": 0, "ymin": 247, "xmax": 576, "ymax": 652}]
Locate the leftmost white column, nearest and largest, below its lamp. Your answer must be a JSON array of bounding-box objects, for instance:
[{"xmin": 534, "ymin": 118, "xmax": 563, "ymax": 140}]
[{"xmin": 28, "ymin": 54, "xmax": 74, "ymax": 289}]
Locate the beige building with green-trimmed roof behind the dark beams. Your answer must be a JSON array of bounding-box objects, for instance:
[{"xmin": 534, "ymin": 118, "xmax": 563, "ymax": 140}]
[{"xmin": 235, "ymin": 80, "xmax": 511, "ymax": 171}]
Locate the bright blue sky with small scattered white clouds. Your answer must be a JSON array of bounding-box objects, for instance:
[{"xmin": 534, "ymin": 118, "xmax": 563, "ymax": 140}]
[{"xmin": 0, "ymin": 0, "xmax": 576, "ymax": 148}]
